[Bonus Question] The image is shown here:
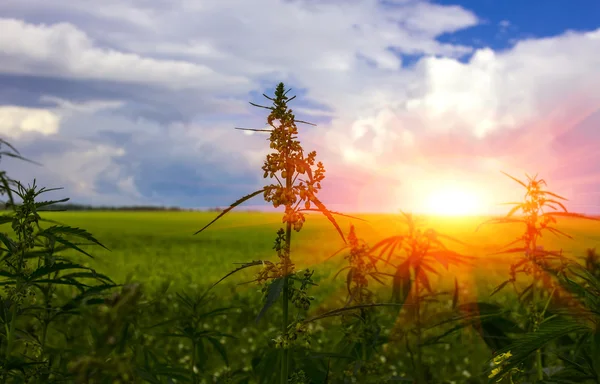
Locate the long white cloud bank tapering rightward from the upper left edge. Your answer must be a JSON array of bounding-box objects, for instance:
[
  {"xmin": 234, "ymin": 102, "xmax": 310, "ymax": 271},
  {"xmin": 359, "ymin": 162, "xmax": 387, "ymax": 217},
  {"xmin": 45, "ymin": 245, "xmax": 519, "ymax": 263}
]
[{"xmin": 0, "ymin": 19, "xmax": 248, "ymax": 90}]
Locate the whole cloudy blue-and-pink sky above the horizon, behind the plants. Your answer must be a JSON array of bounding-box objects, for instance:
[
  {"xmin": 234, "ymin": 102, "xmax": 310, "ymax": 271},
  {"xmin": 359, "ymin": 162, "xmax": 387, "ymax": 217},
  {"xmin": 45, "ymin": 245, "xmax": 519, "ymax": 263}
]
[{"xmin": 0, "ymin": 0, "xmax": 600, "ymax": 214}]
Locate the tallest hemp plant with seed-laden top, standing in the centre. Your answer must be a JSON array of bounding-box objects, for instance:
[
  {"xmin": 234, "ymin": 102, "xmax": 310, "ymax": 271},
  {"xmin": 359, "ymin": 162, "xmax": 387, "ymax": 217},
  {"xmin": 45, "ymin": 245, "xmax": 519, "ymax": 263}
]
[{"xmin": 196, "ymin": 83, "xmax": 345, "ymax": 383}]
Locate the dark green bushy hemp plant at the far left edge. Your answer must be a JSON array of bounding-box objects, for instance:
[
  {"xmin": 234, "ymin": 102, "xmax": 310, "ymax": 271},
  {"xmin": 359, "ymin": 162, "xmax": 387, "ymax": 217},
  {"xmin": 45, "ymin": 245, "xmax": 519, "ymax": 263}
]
[{"xmin": 0, "ymin": 137, "xmax": 115, "ymax": 383}]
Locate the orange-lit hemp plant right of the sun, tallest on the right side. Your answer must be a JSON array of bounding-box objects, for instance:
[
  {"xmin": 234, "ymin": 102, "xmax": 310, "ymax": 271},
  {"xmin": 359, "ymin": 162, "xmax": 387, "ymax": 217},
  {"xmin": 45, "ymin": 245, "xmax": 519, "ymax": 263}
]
[{"xmin": 478, "ymin": 172, "xmax": 597, "ymax": 381}]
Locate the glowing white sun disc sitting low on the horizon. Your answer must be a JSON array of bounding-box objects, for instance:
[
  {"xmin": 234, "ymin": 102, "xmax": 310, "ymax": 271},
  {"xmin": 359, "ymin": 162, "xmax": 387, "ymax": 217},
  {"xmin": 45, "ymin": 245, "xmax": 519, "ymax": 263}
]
[{"xmin": 424, "ymin": 186, "xmax": 482, "ymax": 216}]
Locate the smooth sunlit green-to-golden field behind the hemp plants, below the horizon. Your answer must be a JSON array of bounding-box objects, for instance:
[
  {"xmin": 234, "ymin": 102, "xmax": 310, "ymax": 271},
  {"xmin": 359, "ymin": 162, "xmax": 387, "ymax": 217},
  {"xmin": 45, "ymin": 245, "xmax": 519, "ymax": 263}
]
[{"xmin": 34, "ymin": 212, "xmax": 600, "ymax": 294}]
